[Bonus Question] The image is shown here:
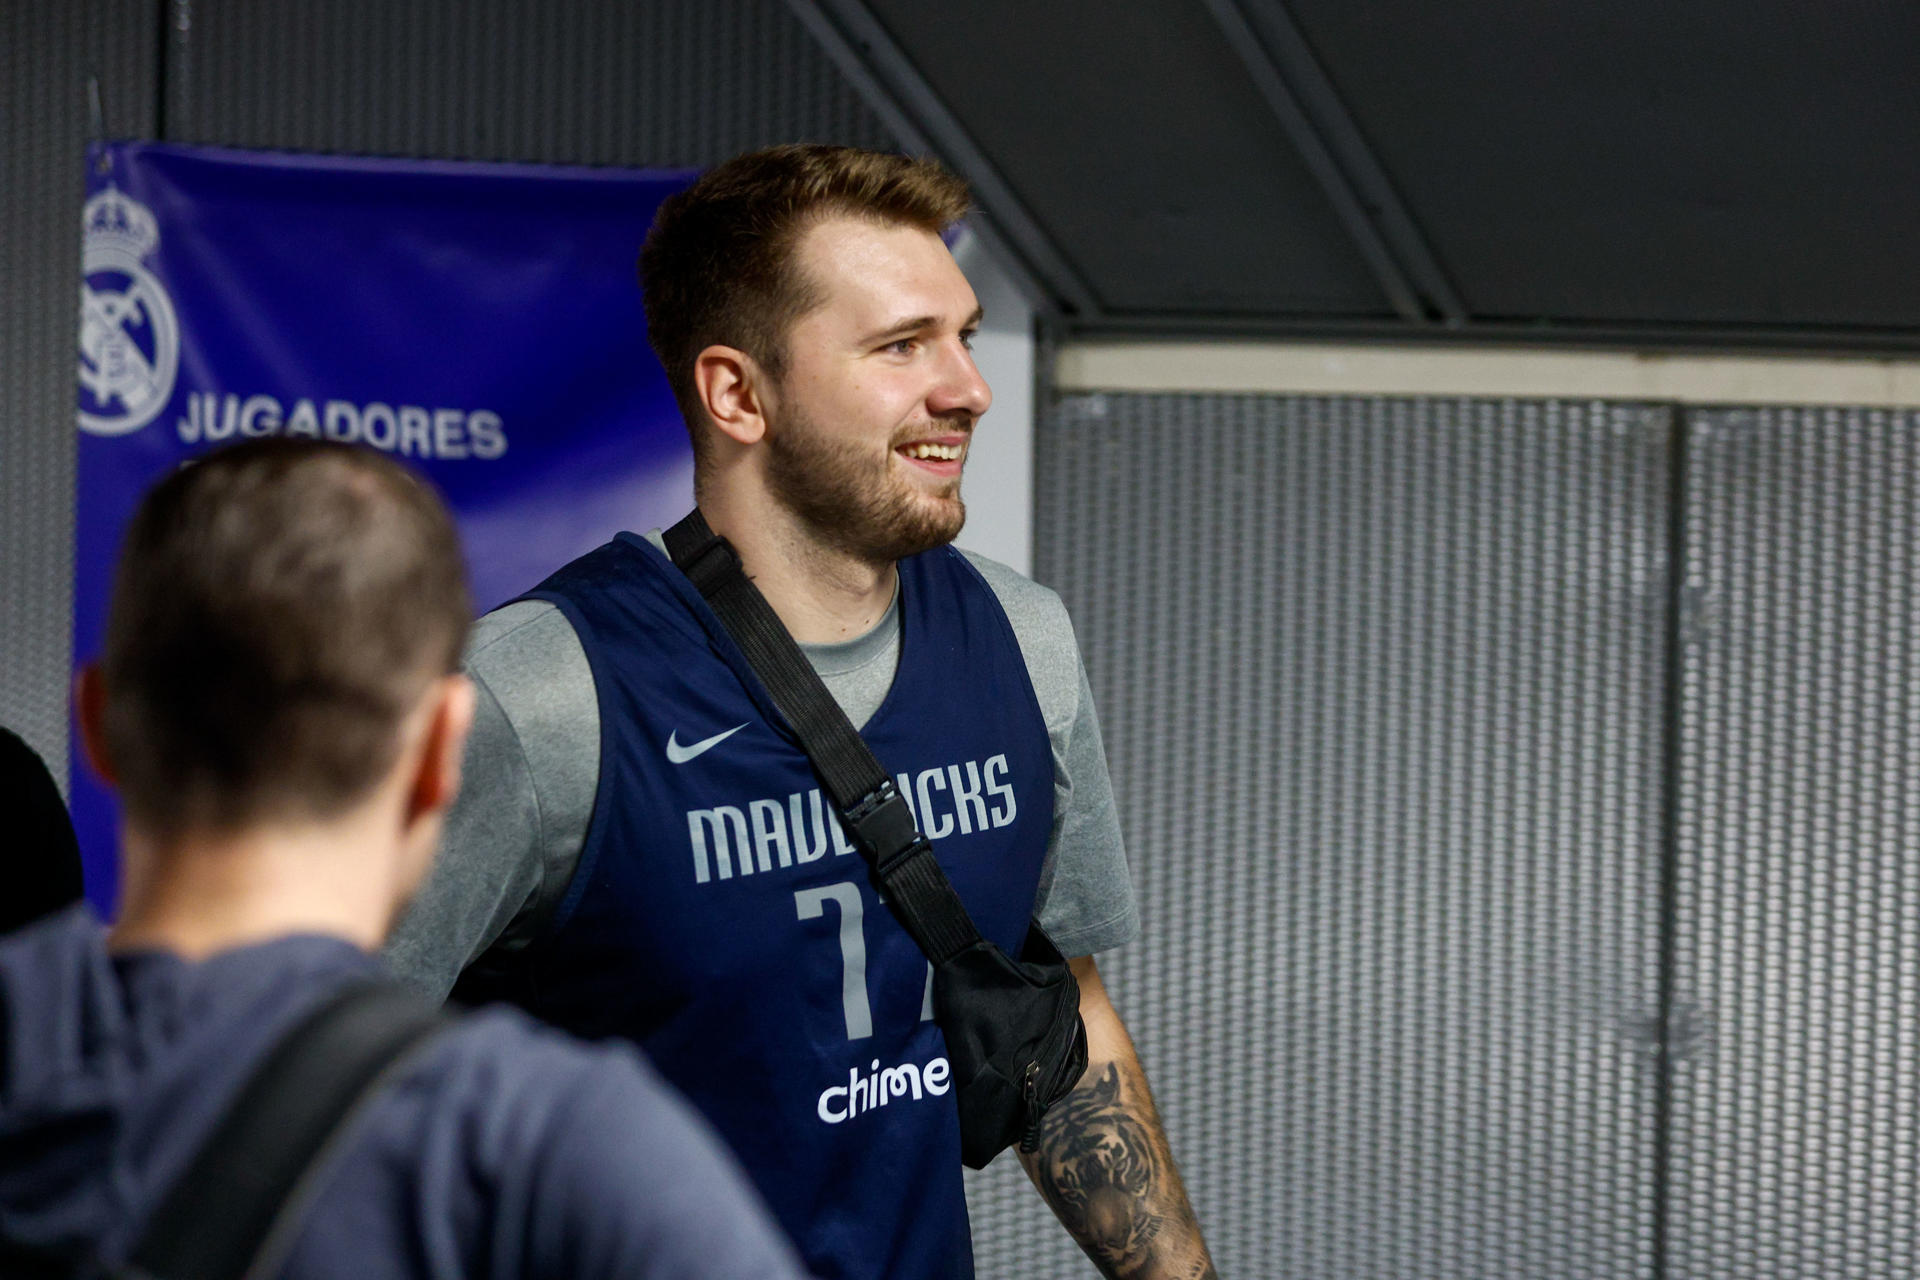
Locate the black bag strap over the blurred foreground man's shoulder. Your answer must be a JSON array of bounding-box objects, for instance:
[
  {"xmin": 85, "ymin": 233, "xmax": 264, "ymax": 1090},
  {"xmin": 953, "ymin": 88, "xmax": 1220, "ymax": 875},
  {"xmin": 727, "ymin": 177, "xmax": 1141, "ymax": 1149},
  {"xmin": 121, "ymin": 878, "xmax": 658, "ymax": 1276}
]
[{"xmin": 123, "ymin": 981, "xmax": 453, "ymax": 1280}]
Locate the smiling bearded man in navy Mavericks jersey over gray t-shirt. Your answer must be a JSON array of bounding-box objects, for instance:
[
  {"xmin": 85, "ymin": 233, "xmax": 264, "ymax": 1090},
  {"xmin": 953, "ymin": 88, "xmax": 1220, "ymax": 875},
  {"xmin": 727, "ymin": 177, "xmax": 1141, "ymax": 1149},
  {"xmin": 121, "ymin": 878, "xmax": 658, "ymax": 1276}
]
[{"xmin": 380, "ymin": 146, "xmax": 1212, "ymax": 1280}]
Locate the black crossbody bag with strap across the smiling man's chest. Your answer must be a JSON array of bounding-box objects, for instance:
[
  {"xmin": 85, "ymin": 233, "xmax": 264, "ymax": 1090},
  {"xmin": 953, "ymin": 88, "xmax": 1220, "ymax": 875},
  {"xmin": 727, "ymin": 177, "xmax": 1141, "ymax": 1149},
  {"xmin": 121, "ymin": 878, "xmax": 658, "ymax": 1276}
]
[{"xmin": 666, "ymin": 510, "xmax": 1087, "ymax": 1169}]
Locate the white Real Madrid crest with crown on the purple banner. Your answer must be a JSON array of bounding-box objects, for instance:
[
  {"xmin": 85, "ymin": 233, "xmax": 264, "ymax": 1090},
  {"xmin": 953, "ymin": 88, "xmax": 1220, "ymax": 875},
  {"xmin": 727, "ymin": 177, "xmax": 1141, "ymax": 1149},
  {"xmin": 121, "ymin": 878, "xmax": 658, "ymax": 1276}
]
[{"xmin": 81, "ymin": 186, "xmax": 180, "ymax": 436}]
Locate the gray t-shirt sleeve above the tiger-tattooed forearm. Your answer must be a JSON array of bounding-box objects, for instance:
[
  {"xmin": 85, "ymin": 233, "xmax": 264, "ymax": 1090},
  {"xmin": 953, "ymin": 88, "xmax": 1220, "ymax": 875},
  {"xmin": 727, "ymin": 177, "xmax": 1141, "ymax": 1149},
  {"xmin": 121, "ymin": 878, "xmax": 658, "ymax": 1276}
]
[{"xmin": 964, "ymin": 551, "xmax": 1140, "ymax": 956}]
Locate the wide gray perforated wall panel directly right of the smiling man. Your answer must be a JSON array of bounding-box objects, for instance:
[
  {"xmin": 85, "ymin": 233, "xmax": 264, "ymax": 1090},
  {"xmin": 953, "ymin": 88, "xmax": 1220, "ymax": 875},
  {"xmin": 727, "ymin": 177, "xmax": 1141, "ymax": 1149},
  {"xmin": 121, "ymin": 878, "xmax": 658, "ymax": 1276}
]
[{"xmin": 972, "ymin": 395, "xmax": 1670, "ymax": 1280}]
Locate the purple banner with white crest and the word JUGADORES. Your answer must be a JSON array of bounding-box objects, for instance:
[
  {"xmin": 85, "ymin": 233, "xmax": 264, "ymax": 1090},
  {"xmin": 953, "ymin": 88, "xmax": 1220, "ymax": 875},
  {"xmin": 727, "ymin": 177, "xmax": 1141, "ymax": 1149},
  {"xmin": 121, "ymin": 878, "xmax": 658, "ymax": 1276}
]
[{"xmin": 71, "ymin": 142, "xmax": 693, "ymax": 915}]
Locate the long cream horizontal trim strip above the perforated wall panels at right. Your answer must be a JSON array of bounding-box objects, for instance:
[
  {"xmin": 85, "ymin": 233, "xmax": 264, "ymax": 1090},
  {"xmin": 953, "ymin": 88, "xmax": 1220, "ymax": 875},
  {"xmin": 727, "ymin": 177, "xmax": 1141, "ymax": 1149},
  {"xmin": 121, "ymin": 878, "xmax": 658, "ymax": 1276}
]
[{"xmin": 1054, "ymin": 340, "xmax": 1920, "ymax": 409}]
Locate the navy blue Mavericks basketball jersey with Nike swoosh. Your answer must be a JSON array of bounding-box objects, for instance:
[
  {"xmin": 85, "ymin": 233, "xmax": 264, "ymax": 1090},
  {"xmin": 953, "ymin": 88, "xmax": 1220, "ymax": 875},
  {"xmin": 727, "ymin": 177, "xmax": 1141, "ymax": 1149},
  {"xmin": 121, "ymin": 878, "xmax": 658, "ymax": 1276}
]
[{"xmin": 459, "ymin": 533, "xmax": 1054, "ymax": 1280}]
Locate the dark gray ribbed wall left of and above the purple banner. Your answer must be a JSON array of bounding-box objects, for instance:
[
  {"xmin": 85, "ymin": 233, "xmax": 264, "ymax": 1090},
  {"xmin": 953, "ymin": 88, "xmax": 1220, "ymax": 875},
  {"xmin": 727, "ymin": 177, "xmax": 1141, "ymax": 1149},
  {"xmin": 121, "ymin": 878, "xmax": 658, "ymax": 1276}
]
[{"xmin": 0, "ymin": 0, "xmax": 893, "ymax": 790}]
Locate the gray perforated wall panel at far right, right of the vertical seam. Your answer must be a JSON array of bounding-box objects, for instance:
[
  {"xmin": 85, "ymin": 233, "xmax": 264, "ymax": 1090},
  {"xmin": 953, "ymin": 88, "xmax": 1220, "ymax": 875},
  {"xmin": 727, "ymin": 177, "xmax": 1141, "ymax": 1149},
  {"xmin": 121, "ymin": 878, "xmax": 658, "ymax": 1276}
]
[{"xmin": 1668, "ymin": 409, "xmax": 1920, "ymax": 1280}]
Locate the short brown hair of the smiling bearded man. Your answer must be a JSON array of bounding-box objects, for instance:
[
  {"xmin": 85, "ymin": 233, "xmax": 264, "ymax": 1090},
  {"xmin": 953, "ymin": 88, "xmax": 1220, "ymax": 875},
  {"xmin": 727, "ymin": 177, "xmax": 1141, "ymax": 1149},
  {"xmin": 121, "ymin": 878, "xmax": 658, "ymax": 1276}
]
[{"xmin": 639, "ymin": 144, "xmax": 970, "ymax": 449}]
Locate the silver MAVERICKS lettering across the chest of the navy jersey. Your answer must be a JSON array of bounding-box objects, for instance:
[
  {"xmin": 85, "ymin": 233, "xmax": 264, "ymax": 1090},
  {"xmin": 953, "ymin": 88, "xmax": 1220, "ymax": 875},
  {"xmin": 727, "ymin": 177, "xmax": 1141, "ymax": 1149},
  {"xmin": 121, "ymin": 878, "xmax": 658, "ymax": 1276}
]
[{"xmin": 687, "ymin": 754, "xmax": 1020, "ymax": 885}]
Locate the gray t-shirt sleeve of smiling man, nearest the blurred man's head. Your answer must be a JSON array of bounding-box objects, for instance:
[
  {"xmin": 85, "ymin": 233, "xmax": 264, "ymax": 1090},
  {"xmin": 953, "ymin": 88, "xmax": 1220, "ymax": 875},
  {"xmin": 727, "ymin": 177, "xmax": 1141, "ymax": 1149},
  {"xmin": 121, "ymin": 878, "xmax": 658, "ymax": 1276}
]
[{"xmin": 386, "ymin": 601, "xmax": 599, "ymax": 998}]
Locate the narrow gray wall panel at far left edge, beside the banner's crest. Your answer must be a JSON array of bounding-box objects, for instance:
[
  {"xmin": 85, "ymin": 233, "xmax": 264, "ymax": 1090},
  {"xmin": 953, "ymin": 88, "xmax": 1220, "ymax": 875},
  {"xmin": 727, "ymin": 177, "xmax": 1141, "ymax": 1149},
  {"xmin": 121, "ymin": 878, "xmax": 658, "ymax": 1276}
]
[{"xmin": 0, "ymin": 0, "xmax": 156, "ymax": 779}]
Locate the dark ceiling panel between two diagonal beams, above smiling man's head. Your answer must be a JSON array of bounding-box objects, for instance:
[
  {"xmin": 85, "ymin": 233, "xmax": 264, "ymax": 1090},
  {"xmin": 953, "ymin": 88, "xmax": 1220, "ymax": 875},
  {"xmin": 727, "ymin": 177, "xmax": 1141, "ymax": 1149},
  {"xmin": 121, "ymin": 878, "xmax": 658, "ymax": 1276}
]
[{"xmin": 868, "ymin": 0, "xmax": 1392, "ymax": 319}]
